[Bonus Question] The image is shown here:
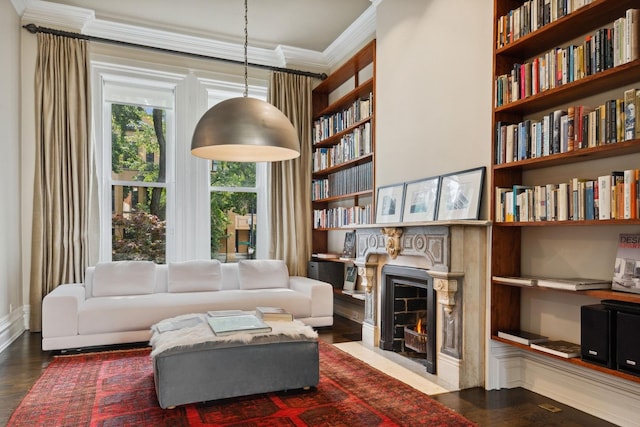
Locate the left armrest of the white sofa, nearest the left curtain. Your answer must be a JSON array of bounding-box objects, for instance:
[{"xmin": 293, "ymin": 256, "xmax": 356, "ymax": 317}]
[{"xmin": 42, "ymin": 283, "xmax": 85, "ymax": 338}]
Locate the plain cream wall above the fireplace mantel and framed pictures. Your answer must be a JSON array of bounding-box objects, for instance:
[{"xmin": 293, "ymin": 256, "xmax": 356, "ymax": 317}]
[{"xmin": 376, "ymin": 0, "xmax": 493, "ymax": 218}]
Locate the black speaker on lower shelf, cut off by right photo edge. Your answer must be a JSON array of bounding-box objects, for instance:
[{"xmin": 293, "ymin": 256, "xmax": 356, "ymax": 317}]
[{"xmin": 616, "ymin": 311, "xmax": 640, "ymax": 376}]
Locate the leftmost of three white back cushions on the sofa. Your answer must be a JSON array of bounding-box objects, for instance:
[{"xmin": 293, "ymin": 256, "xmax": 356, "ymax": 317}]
[{"xmin": 93, "ymin": 261, "xmax": 156, "ymax": 297}]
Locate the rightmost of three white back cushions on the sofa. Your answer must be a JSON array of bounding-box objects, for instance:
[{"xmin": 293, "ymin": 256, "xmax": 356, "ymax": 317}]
[{"xmin": 238, "ymin": 259, "xmax": 289, "ymax": 289}]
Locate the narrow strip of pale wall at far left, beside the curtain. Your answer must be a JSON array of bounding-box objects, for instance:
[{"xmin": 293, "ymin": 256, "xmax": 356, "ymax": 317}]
[{"xmin": 0, "ymin": 1, "xmax": 24, "ymax": 351}]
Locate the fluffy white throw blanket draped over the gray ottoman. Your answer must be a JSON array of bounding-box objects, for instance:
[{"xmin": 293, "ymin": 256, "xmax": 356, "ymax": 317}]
[{"xmin": 149, "ymin": 313, "xmax": 318, "ymax": 357}]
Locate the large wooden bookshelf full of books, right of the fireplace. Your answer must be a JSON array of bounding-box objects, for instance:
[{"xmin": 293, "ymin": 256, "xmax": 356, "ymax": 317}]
[{"xmin": 490, "ymin": 0, "xmax": 640, "ymax": 382}]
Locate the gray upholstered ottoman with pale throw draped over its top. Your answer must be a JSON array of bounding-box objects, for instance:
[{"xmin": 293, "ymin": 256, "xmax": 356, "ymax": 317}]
[{"xmin": 150, "ymin": 314, "xmax": 320, "ymax": 408}]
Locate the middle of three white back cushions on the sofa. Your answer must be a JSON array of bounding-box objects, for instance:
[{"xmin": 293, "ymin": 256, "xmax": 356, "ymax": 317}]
[{"xmin": 168, "ymin": 259, "xmax": 222, "ymax": 292}]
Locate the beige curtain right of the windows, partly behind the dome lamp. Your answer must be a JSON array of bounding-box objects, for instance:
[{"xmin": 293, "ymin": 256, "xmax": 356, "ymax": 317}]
[{"xmin": 269, "ymin": 72, "xmax": 312, "ymax": 276}]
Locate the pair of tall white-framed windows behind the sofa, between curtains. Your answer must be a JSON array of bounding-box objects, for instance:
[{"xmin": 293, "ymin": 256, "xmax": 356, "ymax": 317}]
[{"xmin": 92, "ymin": 58, "xmax": 267, "ymax": 263}]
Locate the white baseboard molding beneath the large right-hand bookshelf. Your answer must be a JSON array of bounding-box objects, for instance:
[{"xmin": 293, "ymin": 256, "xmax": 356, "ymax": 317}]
[{"xmin": 487, "ymin": 342, "xmax": 640, "ymax": 427}]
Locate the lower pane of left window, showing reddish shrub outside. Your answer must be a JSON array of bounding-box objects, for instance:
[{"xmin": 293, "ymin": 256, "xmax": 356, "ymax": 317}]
[{"xmin": 111, "ymin": 185, "xmax": 166, "ymax": 264}]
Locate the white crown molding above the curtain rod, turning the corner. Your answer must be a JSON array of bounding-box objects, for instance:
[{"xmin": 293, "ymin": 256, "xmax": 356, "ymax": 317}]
[{"xmin": 21, "ymin": 0, "xmax": 382, "ymax": 72}]
